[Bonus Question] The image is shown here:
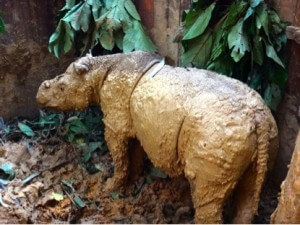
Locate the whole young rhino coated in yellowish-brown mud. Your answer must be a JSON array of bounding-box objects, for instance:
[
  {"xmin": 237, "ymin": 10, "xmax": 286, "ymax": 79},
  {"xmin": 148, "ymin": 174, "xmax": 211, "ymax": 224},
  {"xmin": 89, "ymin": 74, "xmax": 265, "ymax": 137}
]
[{"xmin": 37, "ymin": 52, "xmax": 277, "ymax": 223}]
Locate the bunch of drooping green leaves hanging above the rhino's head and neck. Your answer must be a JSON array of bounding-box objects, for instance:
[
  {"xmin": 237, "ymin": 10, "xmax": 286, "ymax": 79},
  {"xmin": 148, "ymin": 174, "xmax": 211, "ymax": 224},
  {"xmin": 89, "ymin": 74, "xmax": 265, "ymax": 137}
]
[{"xmin": 49, "ymin": 0, "xmax": 156, "ymax": 57}]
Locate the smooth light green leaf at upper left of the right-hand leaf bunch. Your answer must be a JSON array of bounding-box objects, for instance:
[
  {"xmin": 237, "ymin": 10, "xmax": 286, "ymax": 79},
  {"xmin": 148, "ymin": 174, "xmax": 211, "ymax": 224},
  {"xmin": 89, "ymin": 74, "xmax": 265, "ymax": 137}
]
[{"xmin": 183, "ymin": 3, "xmax": 216, "ymax": 40}]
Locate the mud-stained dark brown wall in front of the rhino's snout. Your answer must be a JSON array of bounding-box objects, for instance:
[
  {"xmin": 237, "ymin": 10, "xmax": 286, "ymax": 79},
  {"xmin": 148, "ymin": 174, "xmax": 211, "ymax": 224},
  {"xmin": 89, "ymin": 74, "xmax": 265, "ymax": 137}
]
[{"xmin": 0, "ymin": 0, "xmax": 74, "ymax": 120}]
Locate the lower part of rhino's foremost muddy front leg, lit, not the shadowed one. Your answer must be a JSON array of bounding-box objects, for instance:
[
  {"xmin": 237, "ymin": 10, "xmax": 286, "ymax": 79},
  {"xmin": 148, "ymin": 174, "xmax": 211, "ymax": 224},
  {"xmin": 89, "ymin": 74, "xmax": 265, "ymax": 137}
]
[{"xmin": 105, "ymin": 128, "xmax": 129, "ymax": 191}]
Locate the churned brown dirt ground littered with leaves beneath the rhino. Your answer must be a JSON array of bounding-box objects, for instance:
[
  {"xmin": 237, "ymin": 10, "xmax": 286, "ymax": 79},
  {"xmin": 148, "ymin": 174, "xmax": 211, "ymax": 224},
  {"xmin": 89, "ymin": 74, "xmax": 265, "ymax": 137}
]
[{"xmin": 0, "ymin": 137, "xmax": 277, "ymax": 223}]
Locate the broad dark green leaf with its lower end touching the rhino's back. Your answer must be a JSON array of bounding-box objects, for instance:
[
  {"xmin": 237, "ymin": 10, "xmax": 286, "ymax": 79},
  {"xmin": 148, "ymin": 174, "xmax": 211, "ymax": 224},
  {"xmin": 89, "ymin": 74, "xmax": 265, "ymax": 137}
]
[{"xmin": 182, "ymin": 31, "xmax": 212, "ymax": 68}]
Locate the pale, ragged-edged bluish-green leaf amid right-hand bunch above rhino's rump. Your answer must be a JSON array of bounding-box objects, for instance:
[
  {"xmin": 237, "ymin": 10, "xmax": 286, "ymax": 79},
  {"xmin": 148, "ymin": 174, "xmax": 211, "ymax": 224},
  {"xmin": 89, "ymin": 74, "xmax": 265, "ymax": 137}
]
[{"xmin": 228, "ymin": 19, "xmax": 250, "ymax": 62}]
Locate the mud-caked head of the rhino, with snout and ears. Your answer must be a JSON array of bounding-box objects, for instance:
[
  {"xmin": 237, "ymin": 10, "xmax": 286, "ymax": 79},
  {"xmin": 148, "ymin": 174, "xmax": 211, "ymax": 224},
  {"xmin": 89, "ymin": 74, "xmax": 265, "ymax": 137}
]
[{"xmin": 36, "ymin": 55, "xmax": 93, "ymax": 111}]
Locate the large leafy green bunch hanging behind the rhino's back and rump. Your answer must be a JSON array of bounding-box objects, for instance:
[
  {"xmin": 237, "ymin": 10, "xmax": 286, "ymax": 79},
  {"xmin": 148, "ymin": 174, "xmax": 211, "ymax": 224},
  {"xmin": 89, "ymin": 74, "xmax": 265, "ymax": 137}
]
[{"xmin": 179, "ymin": 0, "xmax": 287, "ymax": 110}]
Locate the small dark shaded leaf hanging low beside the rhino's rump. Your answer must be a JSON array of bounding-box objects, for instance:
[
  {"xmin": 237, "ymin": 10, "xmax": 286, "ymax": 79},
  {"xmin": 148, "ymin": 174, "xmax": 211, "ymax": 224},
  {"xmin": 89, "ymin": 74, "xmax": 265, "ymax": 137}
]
[{"xmin": 264, "ymin": 84, "xmax": 282, "ymax": 111}]
